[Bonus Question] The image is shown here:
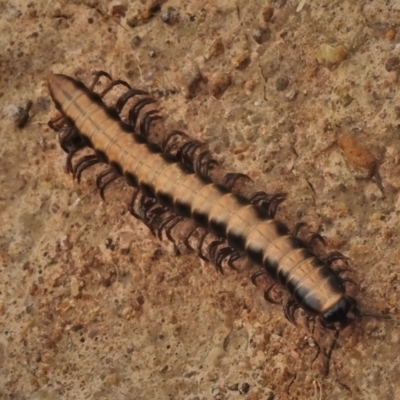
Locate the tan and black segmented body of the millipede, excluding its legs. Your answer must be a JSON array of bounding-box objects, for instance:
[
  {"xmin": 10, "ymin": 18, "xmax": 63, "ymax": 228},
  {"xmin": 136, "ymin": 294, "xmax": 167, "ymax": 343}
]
[{"xmin": 48, "ymin": 74, "xmax": 356, "ymax": 332}]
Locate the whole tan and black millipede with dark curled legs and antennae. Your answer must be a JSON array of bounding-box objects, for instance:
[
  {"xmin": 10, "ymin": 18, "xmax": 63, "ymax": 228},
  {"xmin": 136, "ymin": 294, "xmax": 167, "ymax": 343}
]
[{"xmin": 47, "ymin": 71, "xmax": 389, "ymax": 373}]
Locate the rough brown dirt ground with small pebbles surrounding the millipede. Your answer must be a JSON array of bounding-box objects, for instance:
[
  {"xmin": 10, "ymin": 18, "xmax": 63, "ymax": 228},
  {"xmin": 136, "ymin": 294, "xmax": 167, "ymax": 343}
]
[{"xmin": 0, "ymin": 0, "xmax": 400, "ymax": 400}]
